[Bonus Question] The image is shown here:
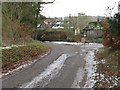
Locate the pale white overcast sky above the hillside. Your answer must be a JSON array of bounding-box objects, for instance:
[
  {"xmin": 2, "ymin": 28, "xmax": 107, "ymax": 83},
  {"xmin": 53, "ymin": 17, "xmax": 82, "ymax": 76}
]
[{"xmin": 42, "ymin": 0, "xmax": 120, "ymax": 17}]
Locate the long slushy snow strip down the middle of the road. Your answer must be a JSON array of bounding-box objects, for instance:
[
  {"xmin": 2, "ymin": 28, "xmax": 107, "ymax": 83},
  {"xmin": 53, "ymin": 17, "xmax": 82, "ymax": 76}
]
[{"xmin": 20, "ymin": 52, "xmax": 77, "ymax": 88}]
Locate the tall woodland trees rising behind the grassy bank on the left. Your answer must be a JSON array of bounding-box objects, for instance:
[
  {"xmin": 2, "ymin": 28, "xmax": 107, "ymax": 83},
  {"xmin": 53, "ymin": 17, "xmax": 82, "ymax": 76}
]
[{"xmin": 2, "ymin": 0, "xmax": 53, "ymax": 44}]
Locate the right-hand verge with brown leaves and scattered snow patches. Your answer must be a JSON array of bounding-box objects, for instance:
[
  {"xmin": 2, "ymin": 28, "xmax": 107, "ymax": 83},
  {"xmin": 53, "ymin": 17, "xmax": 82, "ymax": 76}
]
[{"xmin": 94, "ymin": 48, "xmax": 120, "ymax": 88}]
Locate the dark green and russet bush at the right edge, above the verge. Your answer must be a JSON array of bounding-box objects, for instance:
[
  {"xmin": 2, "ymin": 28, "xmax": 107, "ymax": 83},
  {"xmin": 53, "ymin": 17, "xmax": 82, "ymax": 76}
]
[{"xmin": 102, "ymin": 13, "xmax": 120, "ymax": 49}]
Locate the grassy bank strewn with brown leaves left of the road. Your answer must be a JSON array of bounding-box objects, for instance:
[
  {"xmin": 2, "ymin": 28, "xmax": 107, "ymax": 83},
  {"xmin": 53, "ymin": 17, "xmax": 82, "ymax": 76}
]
[{"xmin": 2, "ymin": 41, "xmax": 49, "ymax": 72}]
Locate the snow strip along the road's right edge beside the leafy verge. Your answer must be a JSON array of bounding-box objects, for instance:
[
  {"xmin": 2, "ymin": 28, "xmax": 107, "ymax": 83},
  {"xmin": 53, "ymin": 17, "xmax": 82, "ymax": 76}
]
[{"xmin": 83, "ymin": 43, "xmax": 103, "ymax": 88}]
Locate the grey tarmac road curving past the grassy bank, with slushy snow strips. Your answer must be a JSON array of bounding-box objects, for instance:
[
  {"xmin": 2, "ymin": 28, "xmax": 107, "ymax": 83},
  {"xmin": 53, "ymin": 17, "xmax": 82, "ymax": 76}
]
[{"xmin": 2, "ymin": 43, "xmax": 103, "ymax": 88}]
